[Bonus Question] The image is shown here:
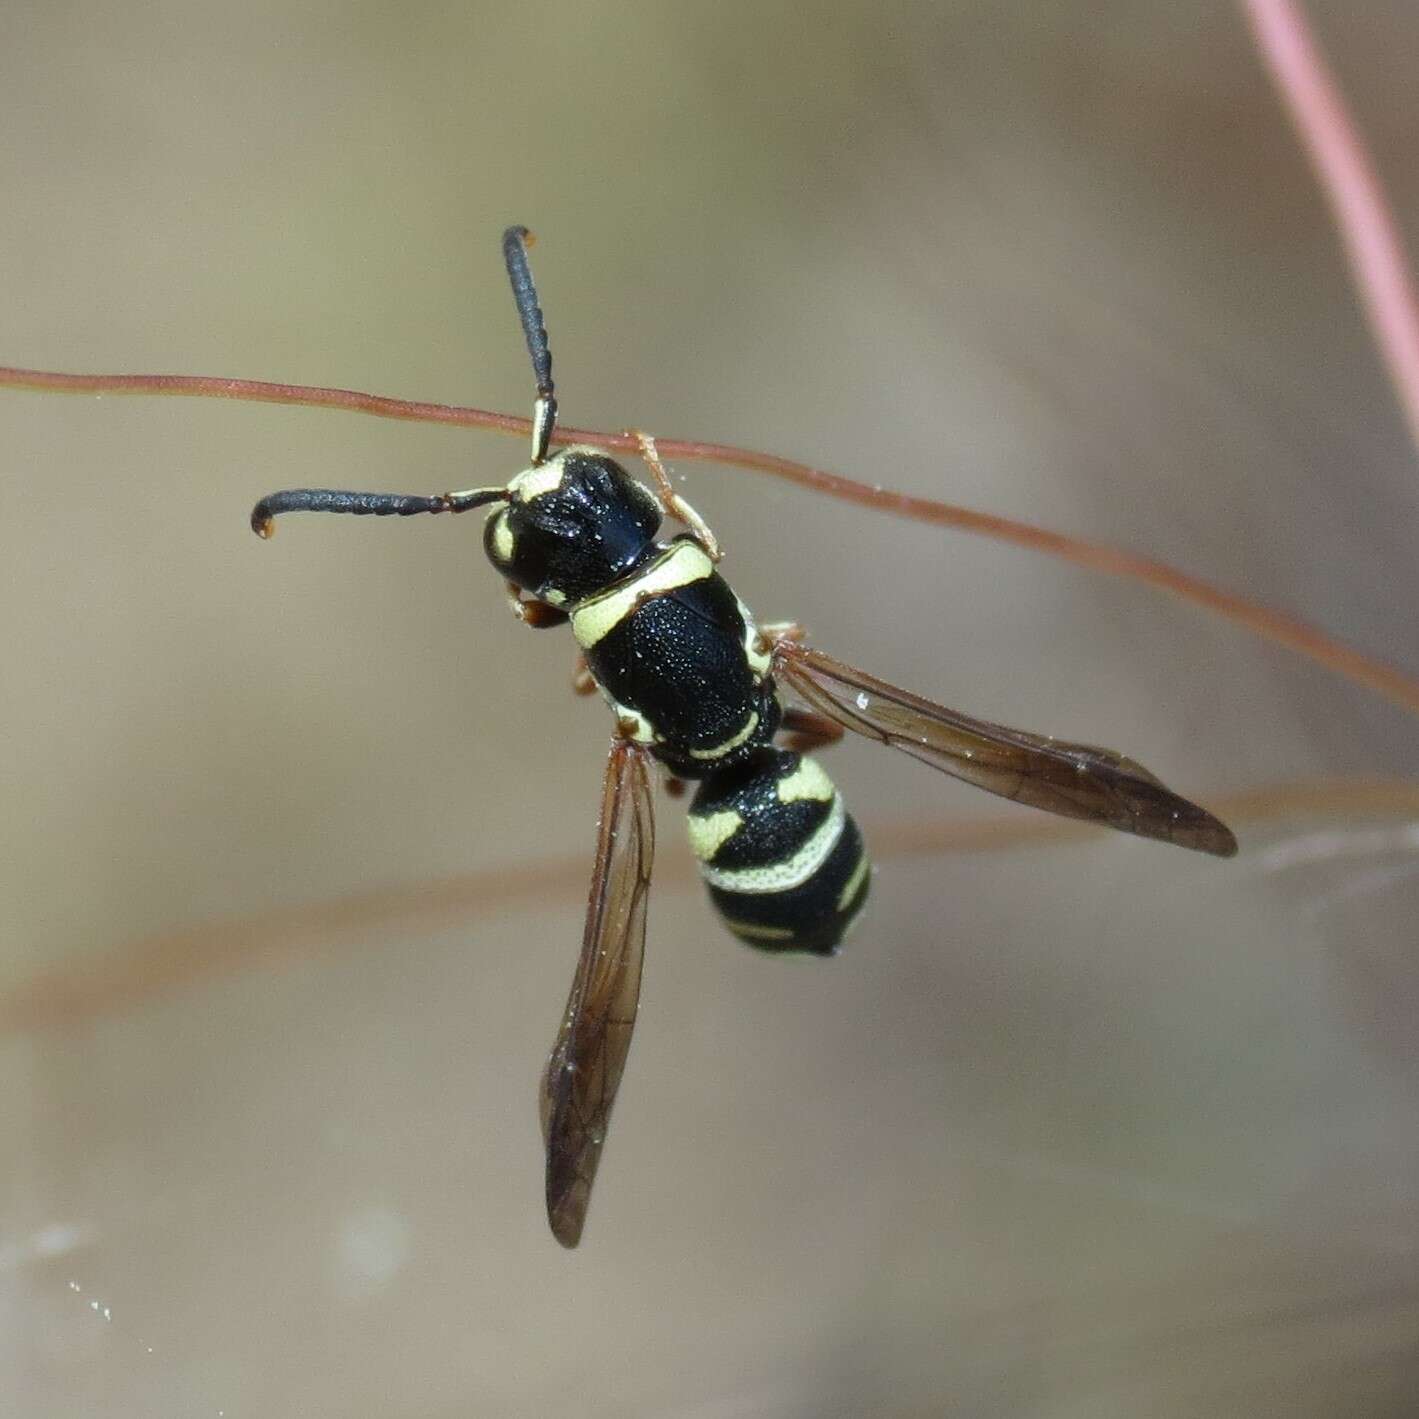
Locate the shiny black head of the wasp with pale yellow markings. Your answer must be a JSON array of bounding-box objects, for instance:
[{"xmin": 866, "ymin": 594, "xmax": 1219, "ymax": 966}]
[{"xmin": 482, "ymin": 447, "xmax": 660, "ymax": 606}]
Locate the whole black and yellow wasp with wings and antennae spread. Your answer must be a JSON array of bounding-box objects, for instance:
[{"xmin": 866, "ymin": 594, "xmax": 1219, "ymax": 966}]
[{"xmin": 251, "ymin": 227, "xmax": 1236, "ymax": 1246}]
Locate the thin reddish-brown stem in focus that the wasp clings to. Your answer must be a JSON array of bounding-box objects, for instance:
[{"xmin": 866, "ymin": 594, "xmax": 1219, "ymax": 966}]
[{"xmin": 0, "ymin": 365, "xmax": 1419, "ymax": 714}]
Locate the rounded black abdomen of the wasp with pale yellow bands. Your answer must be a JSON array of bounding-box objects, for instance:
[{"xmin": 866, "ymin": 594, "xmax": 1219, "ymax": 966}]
[{"xmin": 688, "ymin": 748, "xmax": 871, "ymax": 955}]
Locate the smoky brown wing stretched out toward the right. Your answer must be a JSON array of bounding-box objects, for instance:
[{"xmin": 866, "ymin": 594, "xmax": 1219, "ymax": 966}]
[{"xmin": 773, "ymin": 640, "xmax": 1237, "ymax": 857}]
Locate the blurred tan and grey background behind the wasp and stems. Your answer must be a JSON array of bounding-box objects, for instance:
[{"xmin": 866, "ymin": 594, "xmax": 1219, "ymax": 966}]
[{"xmin": 0, "ymin": 0, "xmax": 1419, "ymax": 1419}]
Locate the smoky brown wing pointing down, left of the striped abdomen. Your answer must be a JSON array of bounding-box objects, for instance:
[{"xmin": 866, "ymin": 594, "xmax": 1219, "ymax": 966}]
[{"xmin": 542, "ymin": 739, "xmax": 656, "ymax": 1247}]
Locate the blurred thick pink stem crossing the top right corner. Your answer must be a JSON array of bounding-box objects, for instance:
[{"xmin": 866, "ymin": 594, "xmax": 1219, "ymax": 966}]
[{"xmin": 1242, "ymin": 0, "xmax": 1419, "ymax": 450}]
